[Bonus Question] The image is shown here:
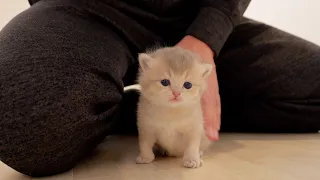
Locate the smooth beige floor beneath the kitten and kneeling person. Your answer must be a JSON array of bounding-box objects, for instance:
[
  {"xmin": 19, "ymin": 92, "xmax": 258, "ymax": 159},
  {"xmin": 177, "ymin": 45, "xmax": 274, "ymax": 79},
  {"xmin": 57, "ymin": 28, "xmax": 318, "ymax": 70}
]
[{"xmin": 0, "ymin": 134, "xmax": 320, "ymax": 180}]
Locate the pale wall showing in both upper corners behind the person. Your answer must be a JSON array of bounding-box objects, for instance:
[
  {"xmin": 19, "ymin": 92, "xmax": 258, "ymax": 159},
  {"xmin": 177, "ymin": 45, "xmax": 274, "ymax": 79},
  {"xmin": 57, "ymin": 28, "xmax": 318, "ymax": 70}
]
[{"xmin": 0, "ymin": 0, "xmax": 320, "ymax": 45}]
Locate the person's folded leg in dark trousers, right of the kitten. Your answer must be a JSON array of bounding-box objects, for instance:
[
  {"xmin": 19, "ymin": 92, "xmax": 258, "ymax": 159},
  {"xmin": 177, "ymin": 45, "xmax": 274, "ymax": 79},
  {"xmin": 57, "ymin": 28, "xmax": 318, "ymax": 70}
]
[{"xmin": 216, "ymin": 19, "xmax": 320, "ymax": 133}]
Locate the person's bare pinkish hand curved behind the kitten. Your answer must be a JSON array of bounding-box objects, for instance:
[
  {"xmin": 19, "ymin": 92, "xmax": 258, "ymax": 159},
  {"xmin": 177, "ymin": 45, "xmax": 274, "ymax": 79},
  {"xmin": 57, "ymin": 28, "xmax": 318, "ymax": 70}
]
[{"xmin": 176, "ymin": 36, "xmax": 221, "ymax": 141}]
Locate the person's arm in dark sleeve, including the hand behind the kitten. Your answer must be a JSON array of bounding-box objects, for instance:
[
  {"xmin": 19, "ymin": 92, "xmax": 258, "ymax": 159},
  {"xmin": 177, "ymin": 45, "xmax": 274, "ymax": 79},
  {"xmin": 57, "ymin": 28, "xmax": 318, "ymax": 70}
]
[{"xmin": 177, "ymin": 0, "xmax": 250, "ymax": 141}]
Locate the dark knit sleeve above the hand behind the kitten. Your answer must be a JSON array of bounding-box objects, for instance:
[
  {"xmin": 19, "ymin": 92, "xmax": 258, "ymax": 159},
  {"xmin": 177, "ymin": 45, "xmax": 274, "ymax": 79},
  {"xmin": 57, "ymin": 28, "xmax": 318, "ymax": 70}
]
[{"xmin": 187, "ymin": 0, "xmax": 250, "ymax": 56}]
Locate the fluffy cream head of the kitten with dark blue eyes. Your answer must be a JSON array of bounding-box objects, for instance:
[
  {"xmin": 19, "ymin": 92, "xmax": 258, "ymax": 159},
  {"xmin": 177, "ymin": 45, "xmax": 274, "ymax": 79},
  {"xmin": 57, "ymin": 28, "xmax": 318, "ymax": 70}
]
[{"xmin": 138, "ymin": 47, "xmax": 212, "ymax": 106}]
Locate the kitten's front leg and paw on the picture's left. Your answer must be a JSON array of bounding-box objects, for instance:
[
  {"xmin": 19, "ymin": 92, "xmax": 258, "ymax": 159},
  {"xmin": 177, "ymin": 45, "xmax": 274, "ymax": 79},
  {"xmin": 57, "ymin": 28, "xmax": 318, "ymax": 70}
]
[{"xmin": 136, "ymin": 131, "xmax": 156, "ymax": 164}]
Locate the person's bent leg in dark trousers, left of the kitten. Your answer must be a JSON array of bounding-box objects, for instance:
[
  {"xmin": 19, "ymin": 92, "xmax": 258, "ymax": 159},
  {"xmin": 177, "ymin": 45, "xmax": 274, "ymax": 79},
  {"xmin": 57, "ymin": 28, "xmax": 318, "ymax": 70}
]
[{"xmin": 0, "ymin": 1, "xmax": 133, "ymax": 176}]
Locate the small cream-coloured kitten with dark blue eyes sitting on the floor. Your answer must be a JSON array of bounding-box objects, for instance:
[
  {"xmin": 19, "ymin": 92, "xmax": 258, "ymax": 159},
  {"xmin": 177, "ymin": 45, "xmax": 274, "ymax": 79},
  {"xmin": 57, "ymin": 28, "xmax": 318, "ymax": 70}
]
[{"xmin": 136, "ymin": 47, "xmax": 212, "ymax": 168}]
